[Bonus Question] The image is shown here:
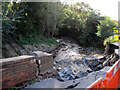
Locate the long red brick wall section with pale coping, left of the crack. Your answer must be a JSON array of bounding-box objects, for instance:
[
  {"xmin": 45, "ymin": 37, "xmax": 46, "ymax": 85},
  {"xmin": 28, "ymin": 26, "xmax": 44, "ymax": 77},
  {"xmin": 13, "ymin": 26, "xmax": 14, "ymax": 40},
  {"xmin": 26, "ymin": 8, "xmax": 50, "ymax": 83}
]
[{"xmin": 0, "ymin": 55, "xmax": 37, "ymax": 88}]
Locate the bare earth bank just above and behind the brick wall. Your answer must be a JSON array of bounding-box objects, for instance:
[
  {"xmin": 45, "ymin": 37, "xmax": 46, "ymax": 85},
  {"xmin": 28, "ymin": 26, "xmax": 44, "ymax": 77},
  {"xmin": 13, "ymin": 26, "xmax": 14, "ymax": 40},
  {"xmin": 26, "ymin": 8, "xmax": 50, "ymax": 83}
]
[{"xmin": 2, "ymin": 44, "xmax": 59, "ymax": 58}]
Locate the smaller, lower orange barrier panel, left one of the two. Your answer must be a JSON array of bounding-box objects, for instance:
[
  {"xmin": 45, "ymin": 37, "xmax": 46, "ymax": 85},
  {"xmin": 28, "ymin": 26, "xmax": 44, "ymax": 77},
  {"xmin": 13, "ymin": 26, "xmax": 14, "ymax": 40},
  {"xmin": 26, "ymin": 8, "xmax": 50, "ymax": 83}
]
[{"xmin": 87, "ymin": 77, "xmax": 104, "ymax": 90}]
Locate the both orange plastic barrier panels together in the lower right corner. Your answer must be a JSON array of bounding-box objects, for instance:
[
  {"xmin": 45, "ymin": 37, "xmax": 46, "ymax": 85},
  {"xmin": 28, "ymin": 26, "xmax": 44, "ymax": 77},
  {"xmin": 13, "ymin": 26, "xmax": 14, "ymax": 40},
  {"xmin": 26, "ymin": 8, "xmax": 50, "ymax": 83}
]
[{"xmin": 87, "ymin": 60, "xmax": 120, "ymax": 90}]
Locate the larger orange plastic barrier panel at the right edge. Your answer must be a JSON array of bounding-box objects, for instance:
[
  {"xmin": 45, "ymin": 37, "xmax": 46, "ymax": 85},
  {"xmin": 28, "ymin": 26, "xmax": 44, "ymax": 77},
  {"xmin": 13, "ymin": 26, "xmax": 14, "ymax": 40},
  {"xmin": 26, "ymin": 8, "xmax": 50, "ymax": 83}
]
[{"xmin": 104, "ymin": 60, "xmax": 120, "ymax": 88}]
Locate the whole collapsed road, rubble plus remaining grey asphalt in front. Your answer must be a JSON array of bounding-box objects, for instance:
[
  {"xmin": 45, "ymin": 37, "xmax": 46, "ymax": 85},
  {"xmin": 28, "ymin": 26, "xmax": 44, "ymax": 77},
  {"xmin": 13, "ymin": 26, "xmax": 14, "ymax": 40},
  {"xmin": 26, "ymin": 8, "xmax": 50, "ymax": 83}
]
[{"xmin": 23, "ymin": 41, "xmax": 119, "ymax": 89}]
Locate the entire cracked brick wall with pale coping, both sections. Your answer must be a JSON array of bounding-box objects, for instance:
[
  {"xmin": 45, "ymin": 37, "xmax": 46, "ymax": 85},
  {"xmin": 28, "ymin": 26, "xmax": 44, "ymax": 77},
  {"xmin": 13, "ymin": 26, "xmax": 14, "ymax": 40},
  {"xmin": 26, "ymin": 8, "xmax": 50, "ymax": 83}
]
[{"xmin": 0, "ymin": 51, "xmax": 53, "ymax": 88}]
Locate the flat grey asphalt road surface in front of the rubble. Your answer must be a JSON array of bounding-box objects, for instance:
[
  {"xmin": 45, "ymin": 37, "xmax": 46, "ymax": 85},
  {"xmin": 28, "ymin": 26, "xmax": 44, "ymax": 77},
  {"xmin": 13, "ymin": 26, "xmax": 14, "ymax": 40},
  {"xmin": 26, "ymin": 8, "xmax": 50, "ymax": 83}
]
[{"xmin": 26, "ymin": 67, "xmax": 110, "ymax": 89}]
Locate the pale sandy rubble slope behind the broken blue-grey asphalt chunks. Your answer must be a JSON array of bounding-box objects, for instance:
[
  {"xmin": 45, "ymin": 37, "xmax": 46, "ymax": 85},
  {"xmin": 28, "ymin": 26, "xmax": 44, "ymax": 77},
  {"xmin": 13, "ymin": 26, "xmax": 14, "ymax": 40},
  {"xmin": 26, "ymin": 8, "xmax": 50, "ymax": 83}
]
[{"xmin": 55, "ymin": 40, "xmax": 102, "ymax": 61}]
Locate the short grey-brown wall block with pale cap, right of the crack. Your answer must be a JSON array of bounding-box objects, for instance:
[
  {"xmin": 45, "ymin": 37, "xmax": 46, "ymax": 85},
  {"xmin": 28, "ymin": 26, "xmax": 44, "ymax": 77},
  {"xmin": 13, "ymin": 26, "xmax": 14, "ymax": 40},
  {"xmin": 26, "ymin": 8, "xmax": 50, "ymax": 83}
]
[{"xmin": 30, "ymin": 51, "xmax": 54, "ymax": 73}]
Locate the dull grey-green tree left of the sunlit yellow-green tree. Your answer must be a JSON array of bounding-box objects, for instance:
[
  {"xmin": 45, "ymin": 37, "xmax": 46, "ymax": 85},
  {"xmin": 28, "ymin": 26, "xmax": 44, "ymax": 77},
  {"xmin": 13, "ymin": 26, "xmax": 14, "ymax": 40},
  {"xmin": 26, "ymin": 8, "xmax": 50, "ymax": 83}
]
[{"xmin": 31, "ymin": 2, "xmax": 62, "ymax": 37}]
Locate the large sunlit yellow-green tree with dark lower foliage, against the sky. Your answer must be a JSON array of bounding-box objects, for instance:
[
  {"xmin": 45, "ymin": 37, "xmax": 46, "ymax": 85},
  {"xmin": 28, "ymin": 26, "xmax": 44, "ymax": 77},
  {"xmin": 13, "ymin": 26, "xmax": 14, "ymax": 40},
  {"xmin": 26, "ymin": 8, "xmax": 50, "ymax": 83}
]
[{"xmin": 62, "ymin": 2, "xmax": 100, "ymax": 45}]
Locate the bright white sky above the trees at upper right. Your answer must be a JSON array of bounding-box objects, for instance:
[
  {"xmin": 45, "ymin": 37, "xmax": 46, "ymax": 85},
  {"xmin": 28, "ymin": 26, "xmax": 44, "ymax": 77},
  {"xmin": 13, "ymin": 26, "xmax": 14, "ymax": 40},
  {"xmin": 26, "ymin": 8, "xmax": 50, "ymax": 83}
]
[{"xmin": 61, "ymin": 0, "xmax": 120, "ymax": 21}]
